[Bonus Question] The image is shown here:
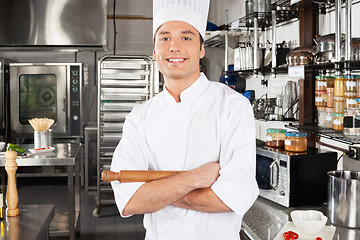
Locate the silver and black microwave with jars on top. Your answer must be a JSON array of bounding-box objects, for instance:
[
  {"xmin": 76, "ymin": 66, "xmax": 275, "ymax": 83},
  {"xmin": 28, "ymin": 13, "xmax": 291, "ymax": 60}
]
[{"xmin": 256, "ymin": 142, "xmax": 337, "ymax": 207}]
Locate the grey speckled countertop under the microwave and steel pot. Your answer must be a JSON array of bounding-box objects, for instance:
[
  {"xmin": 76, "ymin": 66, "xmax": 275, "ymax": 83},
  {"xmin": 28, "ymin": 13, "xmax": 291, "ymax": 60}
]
[{"xmin": 242, "ymin": 197, "xmax": 360, "ymax": 240}]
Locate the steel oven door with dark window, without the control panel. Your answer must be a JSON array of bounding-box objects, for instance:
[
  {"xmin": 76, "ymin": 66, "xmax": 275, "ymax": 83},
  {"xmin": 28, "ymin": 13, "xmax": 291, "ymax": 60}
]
[{"xmin": 10, "ymin": 64, "xmax": 67, "ymax": 135}]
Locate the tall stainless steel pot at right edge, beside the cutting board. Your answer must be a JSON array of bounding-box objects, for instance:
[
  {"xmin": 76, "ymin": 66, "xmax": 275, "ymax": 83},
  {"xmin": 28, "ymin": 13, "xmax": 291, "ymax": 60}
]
[{"xmin": 328, "ymin": 170, "xmax": 360, "ymax": 228}]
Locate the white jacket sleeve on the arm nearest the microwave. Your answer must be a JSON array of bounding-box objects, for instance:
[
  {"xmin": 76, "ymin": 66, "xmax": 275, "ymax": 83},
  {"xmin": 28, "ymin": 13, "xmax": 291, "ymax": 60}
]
[{"xmin": 211, "ymin": 96, "xmax": 259, "ymax": 217}]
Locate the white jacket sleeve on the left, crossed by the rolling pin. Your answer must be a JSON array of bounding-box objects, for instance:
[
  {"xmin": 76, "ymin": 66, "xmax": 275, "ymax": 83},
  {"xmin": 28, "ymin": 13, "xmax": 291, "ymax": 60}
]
[{"xmin": 110, "ymin": 109, "xmax": 148, "ymax": 217}]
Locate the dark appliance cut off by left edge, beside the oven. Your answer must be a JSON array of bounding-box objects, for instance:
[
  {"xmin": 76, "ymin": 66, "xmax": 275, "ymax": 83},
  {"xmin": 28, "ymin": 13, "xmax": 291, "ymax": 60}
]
[{"xmin": 0, "ymin": 58, "xmax": 14, "ymax": 142}]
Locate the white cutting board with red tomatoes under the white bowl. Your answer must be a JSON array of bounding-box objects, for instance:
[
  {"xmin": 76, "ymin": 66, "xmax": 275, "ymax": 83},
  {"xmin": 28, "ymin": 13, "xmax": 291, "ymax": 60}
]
[{"xmin": 274, "ymin": 221, "xmax": 336, "ymax": 240}]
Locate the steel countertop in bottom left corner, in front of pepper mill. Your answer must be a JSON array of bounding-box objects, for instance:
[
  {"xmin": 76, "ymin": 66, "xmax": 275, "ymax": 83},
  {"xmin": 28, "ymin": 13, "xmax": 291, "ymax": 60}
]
[{"xmin": 0, "ymin": 205, "xmax": 55, "ymax": 240}]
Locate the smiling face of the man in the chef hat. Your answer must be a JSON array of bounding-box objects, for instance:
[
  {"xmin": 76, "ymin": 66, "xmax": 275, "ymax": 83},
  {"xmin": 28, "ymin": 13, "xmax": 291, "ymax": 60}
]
[{"xmin": 153, "ymin": 21, "xmax": 205, "ymax": 80}]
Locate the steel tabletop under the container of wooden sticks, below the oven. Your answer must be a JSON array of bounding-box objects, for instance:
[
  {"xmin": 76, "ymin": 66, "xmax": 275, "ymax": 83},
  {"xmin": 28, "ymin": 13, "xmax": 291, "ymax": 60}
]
[{"xmin": 0, "ymin": 143, "xmax": 80, "ymax": 167}]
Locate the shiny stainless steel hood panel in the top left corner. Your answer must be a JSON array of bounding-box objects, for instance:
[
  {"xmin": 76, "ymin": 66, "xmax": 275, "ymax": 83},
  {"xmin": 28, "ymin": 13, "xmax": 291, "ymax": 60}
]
[{"xmin": 0, "ymin": 0, "xmax": 107, "ymax": 49}]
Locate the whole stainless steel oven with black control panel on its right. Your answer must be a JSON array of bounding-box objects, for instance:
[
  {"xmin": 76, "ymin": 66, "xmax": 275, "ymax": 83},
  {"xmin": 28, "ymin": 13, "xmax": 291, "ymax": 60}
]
[{"xmin": 10, "ymin": 63, "xmax": 83, "ymax": 137}]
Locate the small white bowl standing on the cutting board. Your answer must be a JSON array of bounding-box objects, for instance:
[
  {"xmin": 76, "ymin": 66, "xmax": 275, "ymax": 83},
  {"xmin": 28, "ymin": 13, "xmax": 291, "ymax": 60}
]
[{"xmin": 291, "ymin": 210, "xmax": 327, "ymax": 235}]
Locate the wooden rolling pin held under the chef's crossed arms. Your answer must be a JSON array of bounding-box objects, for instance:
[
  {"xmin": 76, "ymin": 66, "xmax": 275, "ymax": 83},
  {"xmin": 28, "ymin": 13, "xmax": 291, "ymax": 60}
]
[{"xmin": 101, "ymin": 170, "xmax": 184, "ymax": 183}]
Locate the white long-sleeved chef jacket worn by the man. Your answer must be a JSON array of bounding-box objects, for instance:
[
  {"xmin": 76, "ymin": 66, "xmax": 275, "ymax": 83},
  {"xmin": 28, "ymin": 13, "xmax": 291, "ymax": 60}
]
[{"xmin": 111, "ymin": 73, "xmax": 259, "ymax": 240}]
